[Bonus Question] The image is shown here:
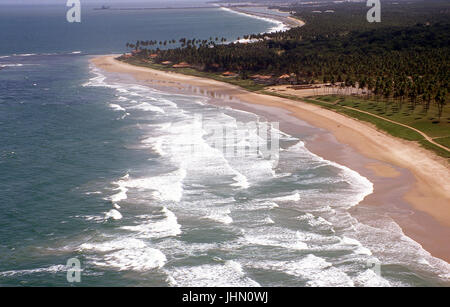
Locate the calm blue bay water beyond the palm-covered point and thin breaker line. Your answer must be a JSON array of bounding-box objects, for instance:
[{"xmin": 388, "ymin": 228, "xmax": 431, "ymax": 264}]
[{"xmin": 0, "ymin": 5, "xmax": 274, "ymax": 55}]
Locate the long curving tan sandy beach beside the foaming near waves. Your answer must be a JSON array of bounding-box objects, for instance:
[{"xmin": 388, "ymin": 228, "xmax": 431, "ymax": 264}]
[{"xmin": 92, "ymin": 55, "xmax": 450, "ymax": 262}]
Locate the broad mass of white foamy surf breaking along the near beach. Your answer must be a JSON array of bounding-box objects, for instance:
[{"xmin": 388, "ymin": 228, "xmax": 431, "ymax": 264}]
[{"xmin": 75, "ymin": 62, "xmax": 448, "ymax": 286}]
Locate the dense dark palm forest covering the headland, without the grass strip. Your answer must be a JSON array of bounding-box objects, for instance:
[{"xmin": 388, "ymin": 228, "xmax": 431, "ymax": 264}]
[{"xmin": 121, "ymin": 0, "xmax": 450, "ymax": 117}]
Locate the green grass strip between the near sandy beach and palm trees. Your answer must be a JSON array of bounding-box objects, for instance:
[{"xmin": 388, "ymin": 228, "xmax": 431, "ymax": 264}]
[{"xmin": 120, "ymin": 58, "xmax": 450, "ymax": 158}]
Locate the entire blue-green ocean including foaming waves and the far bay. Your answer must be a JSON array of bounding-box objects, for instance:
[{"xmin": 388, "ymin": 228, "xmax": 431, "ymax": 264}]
[{"xmin": 0, "ymin": 2, "xmax": 450, "ymax": 287}]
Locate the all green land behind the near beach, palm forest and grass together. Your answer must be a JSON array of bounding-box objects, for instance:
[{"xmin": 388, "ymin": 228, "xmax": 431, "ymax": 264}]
[{"xmin": 120, "ymin": 0, "xmax": 450, "ymax": 158}]
